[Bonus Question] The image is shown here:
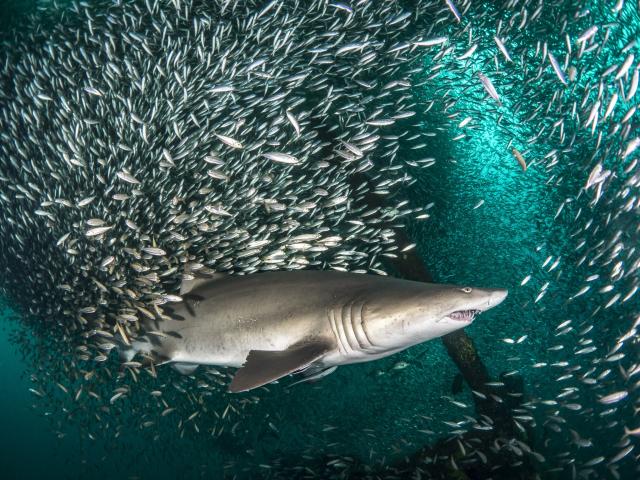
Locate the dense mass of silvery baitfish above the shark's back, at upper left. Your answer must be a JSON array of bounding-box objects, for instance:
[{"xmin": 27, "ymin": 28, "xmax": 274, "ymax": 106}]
[{"xmin": 0, "ymin": 2, "xmax": 430, "ymax": 340}]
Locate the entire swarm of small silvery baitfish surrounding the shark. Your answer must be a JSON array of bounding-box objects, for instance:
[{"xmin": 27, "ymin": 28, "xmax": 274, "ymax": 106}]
[{"xmin": 0, "ymin": 0, "xmax": 640, "ymax": 478}]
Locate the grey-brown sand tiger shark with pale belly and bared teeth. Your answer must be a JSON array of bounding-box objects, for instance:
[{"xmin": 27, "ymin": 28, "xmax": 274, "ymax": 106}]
[{"xmin": 121, "ymin": 270, "xmax": 507, "ymax": 392}]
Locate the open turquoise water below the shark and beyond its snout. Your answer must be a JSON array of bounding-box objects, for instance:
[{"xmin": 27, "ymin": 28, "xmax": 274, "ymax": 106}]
[{"xmin": 0, "ymin": 2, "xmax": 640, "ymax": 479}]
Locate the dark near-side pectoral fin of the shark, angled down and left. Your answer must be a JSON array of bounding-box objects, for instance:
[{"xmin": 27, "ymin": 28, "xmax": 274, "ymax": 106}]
[{"xmin": 229, "ymin": 341, "xmax": 331, "ymax": 393}]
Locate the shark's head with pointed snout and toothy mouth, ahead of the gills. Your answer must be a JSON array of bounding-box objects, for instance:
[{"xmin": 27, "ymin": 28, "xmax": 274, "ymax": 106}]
[{"xmin": 362, "ymin": 282, "xmax": 507, "ymax": 351}]
